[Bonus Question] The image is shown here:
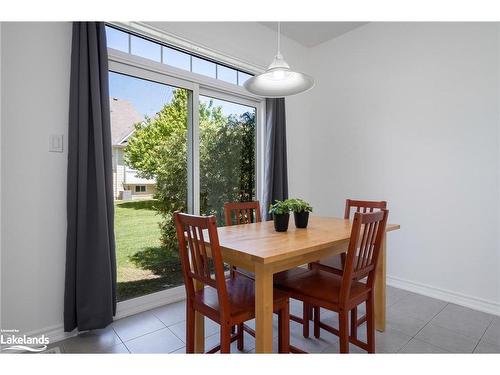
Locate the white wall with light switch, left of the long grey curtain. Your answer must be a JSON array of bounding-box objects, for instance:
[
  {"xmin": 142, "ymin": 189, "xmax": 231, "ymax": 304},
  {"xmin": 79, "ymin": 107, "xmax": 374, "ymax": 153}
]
[{"xmin": 1, "ymin": 23, "xmax": 71, "ymax": 332}]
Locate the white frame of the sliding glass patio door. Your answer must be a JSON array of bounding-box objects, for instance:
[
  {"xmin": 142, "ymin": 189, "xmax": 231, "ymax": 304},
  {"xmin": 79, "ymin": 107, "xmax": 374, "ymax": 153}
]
[{"xmin": 108, "ymin": 44, "xmax": 265, "ymax": 319}]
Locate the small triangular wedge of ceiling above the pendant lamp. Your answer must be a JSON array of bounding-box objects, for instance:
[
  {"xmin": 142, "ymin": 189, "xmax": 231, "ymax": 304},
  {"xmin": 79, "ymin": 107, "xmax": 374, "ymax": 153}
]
[{"xmin": 260, "ymin": 22, "xmax": 367, "ymax": 47}]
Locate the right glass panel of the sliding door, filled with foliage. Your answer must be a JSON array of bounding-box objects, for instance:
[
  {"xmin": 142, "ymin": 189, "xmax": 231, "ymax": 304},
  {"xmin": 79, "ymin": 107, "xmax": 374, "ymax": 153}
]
[{"xmin": 199, "ymin": 95, "xmax": 257, "ymax": 226}]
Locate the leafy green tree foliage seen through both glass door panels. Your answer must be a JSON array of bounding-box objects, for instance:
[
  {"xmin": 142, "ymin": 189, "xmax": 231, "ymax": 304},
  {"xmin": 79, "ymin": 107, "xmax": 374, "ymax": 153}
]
[{"xmin": 125, "ymin": 89, "xmax": 255, "ymax": 254}]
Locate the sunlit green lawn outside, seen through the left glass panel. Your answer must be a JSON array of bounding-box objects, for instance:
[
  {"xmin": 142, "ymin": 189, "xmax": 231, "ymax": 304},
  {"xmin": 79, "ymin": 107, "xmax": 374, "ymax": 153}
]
[{"xmin": 115, "ymin": 200, "xmax": 182, "ymax": 301}]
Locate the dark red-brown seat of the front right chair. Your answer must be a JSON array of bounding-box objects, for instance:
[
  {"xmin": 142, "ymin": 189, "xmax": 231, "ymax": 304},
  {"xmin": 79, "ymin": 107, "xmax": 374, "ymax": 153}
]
[{"xmin": 275, "ymin": 269, "xmax": 368, "ymax": 308}]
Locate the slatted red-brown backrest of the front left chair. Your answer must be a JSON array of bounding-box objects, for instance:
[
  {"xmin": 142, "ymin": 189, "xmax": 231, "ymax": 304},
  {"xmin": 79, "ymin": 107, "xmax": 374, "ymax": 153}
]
[{"xmin": 174, "ymin": 211, "xmax": 229, "ymax": 313}]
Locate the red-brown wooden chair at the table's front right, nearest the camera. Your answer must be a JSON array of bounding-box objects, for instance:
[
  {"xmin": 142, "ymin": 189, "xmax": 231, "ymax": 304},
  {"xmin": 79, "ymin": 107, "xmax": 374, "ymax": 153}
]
[{"xmin": 275, "ymin": 210, "xmax": 389, "ymax": 353}]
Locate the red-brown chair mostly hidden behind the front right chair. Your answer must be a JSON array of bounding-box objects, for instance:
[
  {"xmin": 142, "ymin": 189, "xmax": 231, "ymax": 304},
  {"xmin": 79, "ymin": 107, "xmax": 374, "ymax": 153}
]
[{"xmin": 306, "ymin": 199, "xmax": 387, "ymax": 338}]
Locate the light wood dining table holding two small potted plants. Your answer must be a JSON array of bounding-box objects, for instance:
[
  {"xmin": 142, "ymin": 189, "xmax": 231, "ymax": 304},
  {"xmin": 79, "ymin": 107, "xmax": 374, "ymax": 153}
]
[{"xmin": 195, "ymin": 215, "xmax": 400, "ymax": 353}]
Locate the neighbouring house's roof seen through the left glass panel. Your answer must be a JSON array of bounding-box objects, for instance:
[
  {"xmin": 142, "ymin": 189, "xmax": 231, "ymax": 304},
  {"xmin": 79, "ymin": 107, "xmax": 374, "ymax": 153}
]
[{"xmin": 109, "ymin": 98, "xmax": 143, "ymax": 146}]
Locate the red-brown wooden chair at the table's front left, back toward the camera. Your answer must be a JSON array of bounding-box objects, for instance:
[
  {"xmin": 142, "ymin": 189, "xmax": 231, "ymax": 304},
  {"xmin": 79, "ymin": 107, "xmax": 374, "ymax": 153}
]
[{"xmin": 174, "ymin": 212, "xmax": 290, "ymax": 353}]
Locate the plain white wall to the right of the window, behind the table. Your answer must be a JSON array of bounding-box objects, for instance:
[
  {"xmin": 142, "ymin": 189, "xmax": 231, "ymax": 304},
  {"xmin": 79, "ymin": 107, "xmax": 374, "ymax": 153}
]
[{"xmin": 308, "ymin": 23, "xmax": 500, "ymax": 314}]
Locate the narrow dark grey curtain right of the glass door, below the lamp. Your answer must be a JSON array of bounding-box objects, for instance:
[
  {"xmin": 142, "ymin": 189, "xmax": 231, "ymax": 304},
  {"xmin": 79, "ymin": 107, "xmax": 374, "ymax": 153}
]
[{"xmin": 263, "ymin": 98, "xmax": 288, "ymax": 220}]
